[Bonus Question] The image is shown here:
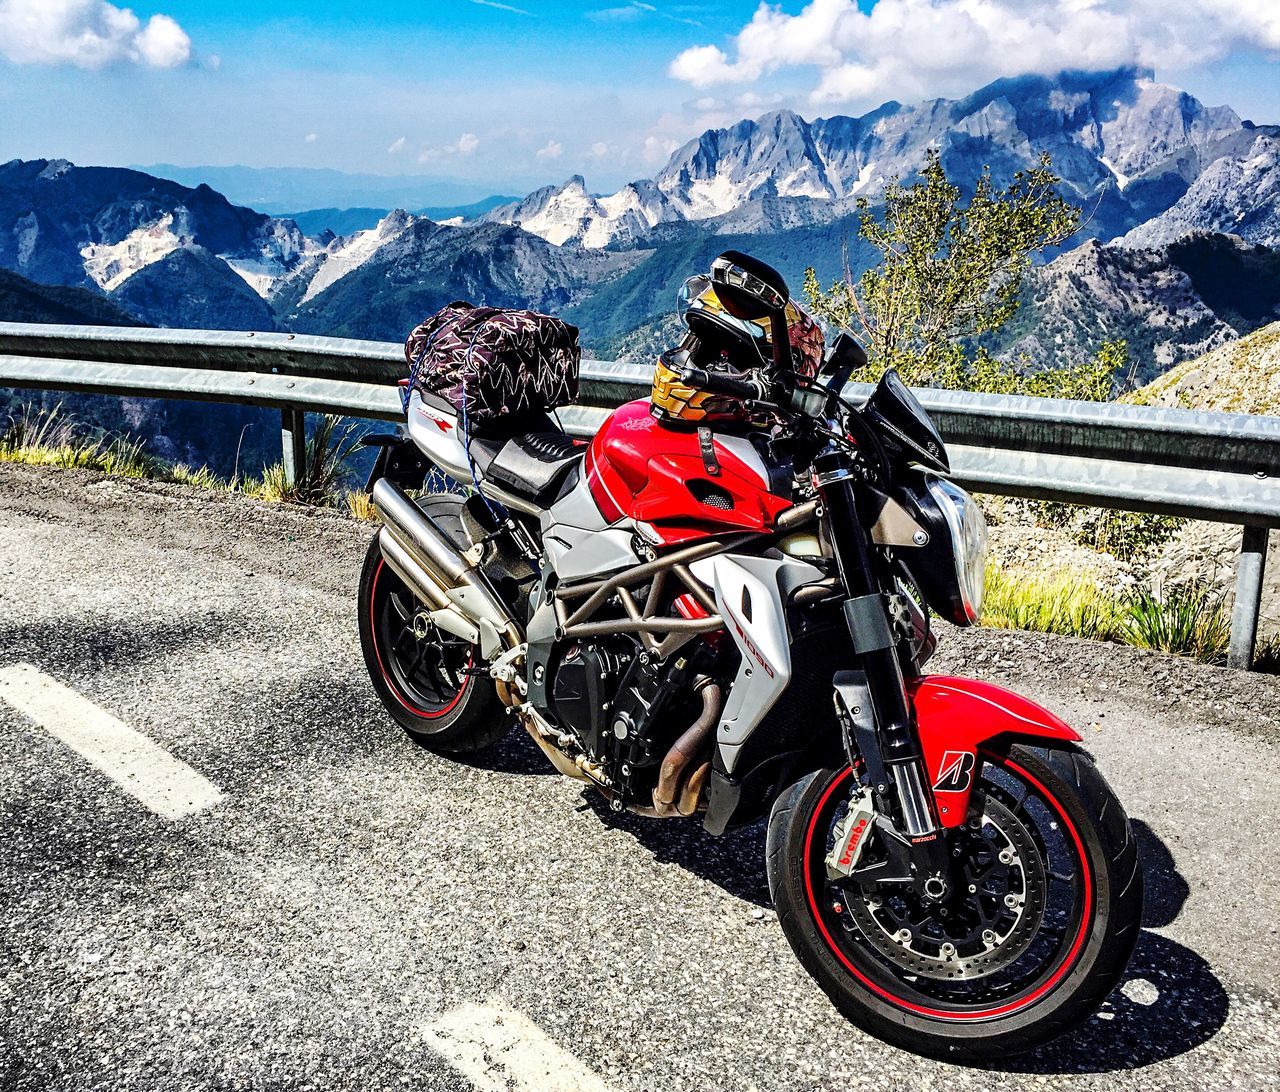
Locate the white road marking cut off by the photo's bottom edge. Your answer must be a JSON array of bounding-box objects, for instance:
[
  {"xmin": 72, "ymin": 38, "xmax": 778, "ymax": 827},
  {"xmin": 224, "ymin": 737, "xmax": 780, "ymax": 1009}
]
[{"xmin": 425, "ymin": 997, "xmax": 612, "ymax": 1092}]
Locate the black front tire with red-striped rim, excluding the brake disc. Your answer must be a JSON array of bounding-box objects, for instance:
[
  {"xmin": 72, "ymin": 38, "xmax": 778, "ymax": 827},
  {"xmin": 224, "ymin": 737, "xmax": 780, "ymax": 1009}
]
[{"xmin": 767, "ymin": 745, "xmax": 1143, "ymax": 1061}]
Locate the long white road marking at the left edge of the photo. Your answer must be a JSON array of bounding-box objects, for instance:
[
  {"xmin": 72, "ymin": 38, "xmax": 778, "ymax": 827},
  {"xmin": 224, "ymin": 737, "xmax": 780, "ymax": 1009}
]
[{"xmin": 0, "ymin": 663, "xmax": 223, "ymax": 819}]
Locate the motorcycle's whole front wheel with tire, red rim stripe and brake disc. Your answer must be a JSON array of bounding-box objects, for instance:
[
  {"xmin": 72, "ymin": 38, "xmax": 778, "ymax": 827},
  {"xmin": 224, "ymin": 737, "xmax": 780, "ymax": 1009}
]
[{"xmin": 768, "ymin": 745, "xmax": 1142, "ymax": 1061}]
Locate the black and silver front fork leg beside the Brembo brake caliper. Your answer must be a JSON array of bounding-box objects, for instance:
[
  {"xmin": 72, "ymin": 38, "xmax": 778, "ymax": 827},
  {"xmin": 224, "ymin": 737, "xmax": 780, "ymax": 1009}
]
[{"xmin": 814, "ymin": 449, "xmax": 946, "ymax": 883}]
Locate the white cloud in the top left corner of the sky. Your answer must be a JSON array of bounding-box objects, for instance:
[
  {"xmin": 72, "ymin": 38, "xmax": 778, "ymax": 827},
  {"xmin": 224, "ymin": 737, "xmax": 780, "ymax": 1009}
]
[{"xmin": 0, "ymin": 0, "xmax": 191, "ymax": 68}]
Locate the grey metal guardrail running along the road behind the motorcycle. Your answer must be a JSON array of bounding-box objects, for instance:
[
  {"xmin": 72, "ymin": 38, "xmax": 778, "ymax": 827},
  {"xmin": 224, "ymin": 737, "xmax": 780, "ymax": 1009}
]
[{"xmin": 0, "ymin": 323, "xmax": 1280, "ymax": 667}]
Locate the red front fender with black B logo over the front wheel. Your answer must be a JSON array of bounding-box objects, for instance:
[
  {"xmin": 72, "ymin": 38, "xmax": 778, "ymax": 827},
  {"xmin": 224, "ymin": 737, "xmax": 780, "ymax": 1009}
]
[{"xmin": 908, "ymin": 675, "xmax": 1080, "ymax": 827}]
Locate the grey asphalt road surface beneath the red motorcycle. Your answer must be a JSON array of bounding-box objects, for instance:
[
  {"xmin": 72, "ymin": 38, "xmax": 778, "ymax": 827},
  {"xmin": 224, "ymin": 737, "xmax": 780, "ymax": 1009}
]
[{"xmin": 0, "ymin": 467, "xmax": 1280, "ymax": 1092}]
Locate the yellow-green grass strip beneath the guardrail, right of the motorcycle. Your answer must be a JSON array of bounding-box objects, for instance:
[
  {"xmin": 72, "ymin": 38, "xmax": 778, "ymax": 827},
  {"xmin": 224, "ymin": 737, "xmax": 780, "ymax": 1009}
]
[{"xmin": 982, "ymin": 566, "xmax": 1264, "ymax": 673}]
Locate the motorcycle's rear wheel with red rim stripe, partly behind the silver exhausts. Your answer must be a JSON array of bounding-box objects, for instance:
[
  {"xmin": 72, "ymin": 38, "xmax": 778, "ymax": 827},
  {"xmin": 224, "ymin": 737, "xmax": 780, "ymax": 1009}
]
[{"xmin": 358, "ymin": 494, "xmax": 511, "ymax": 754}]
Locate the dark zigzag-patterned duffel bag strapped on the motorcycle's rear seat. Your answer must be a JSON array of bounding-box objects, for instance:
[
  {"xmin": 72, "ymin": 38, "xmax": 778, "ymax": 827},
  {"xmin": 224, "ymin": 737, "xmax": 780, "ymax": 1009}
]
[{"xmin": 404, "ymin": 301, "xmax": 581, "ymax": 424}]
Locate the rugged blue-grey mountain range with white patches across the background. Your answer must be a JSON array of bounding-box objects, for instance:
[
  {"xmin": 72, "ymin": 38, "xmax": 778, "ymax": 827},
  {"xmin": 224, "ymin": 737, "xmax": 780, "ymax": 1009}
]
[{"xmin": 0, "ymin": 68, "xmax": 1280, "ymax": 386}]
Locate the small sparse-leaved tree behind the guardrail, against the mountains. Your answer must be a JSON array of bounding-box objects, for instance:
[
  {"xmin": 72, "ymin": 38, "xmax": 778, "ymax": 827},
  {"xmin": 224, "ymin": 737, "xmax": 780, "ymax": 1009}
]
[{"xmin": 804, "ymin": 151, "xmax": 1096, "ymax": 388}]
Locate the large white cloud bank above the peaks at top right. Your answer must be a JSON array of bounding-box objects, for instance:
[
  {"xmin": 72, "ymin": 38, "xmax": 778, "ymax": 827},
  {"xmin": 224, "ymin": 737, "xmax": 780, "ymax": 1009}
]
[{"xmin": 669, "ymin": 0, "xmax": 1280, "ymax": 104}]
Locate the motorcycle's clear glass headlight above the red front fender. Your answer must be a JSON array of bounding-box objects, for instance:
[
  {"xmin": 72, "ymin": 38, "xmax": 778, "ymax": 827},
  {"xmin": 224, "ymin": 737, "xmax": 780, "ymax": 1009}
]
[{"xmin": 901, "ymin": 474, "xmax": 987, "ymax": 626}]
